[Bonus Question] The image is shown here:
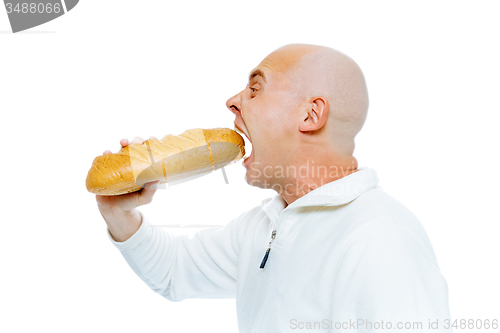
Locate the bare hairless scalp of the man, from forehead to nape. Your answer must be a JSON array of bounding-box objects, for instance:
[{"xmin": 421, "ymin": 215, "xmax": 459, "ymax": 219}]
[{"xmin": 259, "ymin": 44, "xmax": 368, "ymax": 155}]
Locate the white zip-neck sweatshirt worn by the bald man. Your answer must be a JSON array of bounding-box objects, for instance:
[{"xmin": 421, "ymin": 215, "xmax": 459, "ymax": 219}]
[{"xmin": 108, "ymin": 168, "xmax": 452, "ymax": 333}]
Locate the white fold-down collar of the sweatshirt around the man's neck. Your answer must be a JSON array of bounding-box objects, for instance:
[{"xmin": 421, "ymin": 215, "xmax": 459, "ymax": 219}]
[{"xmin": 262, "ymin": 167, "xmax": 379, "ymax": 220}]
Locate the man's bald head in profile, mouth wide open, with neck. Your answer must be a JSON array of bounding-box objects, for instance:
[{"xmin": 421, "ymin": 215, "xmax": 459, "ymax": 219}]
[{"xmin": 226, "ymin": 44, "xmax": 368, "ymax": 202}]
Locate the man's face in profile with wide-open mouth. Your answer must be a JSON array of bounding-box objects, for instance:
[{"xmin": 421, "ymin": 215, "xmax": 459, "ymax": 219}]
[{"xmin": 226, "ymin": 53, "xmax": 298, "ymax": 188}]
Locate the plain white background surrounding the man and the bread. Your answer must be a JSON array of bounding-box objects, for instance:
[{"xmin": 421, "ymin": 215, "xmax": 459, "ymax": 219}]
[{"xmin": 0, "ymin": 0, "xmax": 500, "ymax": 332}]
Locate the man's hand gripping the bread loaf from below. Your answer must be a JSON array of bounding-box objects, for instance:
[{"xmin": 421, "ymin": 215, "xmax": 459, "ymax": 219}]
[{"xmin": 96, "ymin": 137, "xmax": 160, "ymax": 242}]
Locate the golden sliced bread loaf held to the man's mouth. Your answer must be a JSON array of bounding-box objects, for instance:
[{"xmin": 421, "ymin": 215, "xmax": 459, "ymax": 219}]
[{"xmin": 86, "ymin": 128, "xmax": 245, "ymax": 195}]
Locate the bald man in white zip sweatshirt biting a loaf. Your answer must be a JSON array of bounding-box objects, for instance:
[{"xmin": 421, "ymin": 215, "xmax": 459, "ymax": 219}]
[{"xmin": 96, "ymin": 44, "xmax": 450, "ymax": 333}]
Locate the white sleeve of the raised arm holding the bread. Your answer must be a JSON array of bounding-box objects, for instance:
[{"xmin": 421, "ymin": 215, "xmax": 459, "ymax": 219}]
[{"xmin": 107, "ymin": 209, "xmax": 252, "ymax": 301}]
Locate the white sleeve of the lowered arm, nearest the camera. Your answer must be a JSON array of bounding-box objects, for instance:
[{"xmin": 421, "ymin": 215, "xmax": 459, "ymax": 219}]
[{"xmin": 332, "ymin": 220, "xmax": 452, "ymax": 333}]
